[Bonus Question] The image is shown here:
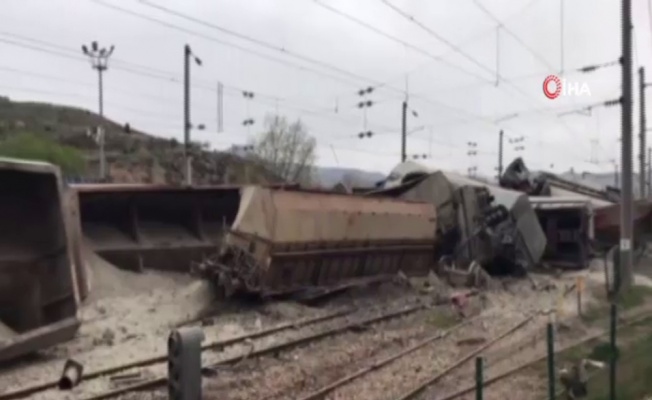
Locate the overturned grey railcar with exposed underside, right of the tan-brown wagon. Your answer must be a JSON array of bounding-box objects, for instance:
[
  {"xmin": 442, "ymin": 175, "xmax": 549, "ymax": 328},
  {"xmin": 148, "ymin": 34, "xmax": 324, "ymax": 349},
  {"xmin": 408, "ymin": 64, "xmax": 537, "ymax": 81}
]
[{"xmin": 369, "ymin": 161, "xmax": 546, "ymax": 275}]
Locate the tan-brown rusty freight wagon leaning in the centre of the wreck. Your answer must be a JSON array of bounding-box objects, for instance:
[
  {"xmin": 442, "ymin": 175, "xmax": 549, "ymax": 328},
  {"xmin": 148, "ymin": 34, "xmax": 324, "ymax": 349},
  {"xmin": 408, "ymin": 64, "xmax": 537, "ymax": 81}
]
[{"xmin": 201, "ymin": 187, "xmax": 436, "ymax": 296}]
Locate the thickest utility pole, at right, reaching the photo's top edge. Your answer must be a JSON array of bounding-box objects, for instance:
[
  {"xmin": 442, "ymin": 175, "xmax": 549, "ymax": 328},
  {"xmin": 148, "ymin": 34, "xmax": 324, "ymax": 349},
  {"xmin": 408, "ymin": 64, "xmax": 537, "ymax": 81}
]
[{"xmin": 619, "ymin": 0, "xmax": 633, "ymax": 288}]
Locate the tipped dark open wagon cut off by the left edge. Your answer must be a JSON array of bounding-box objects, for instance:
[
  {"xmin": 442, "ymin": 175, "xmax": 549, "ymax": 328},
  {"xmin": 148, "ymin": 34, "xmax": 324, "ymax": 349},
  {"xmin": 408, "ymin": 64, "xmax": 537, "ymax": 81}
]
[{"xmin": 0, "ymin": 159, "xmax": 80, "ymax": 361}]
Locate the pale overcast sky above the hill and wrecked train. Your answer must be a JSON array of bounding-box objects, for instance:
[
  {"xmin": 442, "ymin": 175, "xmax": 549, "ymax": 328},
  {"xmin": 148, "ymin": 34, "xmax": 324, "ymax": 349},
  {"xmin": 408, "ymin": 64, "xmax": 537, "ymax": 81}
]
[{"xmin": 0, "ymin": 0, "xmax": 652, "ymax": 175}]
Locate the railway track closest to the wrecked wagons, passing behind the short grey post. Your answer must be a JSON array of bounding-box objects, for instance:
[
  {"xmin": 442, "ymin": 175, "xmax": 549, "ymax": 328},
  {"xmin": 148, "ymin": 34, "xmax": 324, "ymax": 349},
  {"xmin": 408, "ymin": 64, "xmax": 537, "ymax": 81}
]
[{"xmin": 0, "ymin": 294, "xmax": 456, "ymax": 400}]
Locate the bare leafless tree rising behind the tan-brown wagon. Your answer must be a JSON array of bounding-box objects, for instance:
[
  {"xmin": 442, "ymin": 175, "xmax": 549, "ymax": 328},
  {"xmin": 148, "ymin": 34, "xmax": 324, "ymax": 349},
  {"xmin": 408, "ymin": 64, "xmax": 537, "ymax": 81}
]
[{"xmin": 251, "ymin": 115, "xmax": 317, "ymax": 185}]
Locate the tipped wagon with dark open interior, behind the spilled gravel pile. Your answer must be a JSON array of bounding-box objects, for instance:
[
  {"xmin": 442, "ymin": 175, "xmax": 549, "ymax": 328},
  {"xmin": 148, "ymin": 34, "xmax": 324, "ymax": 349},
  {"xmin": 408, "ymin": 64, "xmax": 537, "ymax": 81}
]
[{"xmin": 71, "ymin": 185, "xmax": 240, "ymax": 271}]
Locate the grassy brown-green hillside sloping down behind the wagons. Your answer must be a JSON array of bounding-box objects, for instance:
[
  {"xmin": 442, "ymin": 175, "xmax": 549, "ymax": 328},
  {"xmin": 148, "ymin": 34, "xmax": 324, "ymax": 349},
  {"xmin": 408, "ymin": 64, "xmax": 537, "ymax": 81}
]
[{"xmin": 0, "ymin": 97, "xmax": 278, "ymax": 184}]
